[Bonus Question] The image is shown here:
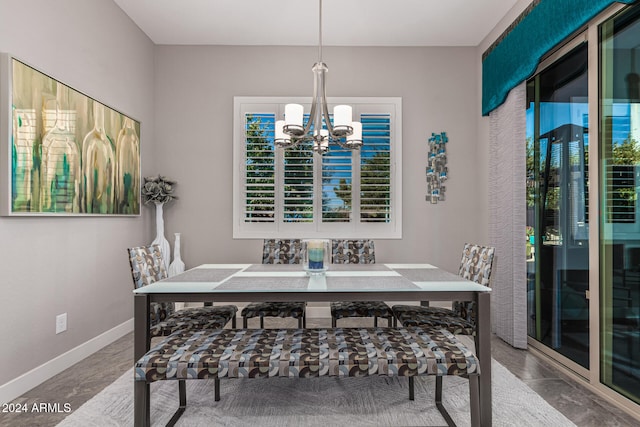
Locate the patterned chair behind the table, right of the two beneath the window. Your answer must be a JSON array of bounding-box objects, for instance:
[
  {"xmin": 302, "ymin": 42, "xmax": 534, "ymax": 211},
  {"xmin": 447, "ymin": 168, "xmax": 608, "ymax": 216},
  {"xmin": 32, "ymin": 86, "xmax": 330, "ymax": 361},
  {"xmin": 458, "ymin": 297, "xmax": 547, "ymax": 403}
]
[{"xmin": 331, "ymin": 240, "xmax": 395, "ymax": 328}]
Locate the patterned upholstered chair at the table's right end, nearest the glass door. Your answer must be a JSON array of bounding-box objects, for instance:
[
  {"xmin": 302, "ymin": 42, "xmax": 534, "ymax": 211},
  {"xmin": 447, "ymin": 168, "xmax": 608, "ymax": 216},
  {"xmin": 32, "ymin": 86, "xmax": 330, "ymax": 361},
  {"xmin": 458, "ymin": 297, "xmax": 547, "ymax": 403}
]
[{"xmin": 392, "ymin": 243, "xmax": 495, "ymax": 342}]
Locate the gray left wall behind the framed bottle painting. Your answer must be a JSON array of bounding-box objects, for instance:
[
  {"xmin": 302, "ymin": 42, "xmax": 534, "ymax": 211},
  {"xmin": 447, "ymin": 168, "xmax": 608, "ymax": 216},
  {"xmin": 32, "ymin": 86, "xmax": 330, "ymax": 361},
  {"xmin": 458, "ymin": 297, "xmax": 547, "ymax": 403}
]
[{"xmin": 0, "ymin": 0, "xmax": 154, "ymax": 385}]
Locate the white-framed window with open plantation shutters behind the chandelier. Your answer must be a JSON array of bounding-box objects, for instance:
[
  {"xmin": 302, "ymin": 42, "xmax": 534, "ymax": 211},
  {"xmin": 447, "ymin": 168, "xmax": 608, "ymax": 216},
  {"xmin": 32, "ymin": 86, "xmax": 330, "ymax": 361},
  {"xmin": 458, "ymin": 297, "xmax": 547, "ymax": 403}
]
[{"xmin": 233, "ymin": 97, "xmax": 402, "ymax": 238}]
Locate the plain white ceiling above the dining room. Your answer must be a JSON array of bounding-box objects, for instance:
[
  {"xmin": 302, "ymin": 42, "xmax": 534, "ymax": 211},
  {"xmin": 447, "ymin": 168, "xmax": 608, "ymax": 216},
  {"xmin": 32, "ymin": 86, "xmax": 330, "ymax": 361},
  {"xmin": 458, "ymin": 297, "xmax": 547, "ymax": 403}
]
[{"xmin": 114, "ymin": 0, "xmax": 518, "ymax": 46}]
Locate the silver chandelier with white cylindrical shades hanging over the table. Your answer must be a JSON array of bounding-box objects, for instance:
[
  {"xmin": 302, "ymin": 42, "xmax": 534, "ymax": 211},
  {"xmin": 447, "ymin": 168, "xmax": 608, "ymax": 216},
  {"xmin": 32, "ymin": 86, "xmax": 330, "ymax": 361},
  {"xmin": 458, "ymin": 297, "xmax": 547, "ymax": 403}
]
[{"xmin": 274, "ymin": 0, "xmax": 362, "ymax": 154}]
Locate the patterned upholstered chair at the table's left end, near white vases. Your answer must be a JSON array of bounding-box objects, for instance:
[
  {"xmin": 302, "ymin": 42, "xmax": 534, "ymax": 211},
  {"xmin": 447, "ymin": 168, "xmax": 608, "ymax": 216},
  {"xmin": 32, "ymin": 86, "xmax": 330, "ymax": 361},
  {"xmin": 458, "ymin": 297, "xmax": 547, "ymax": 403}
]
[{"xmin": 127, "ymin": 245, "xmax": 238, "ymax": 338}]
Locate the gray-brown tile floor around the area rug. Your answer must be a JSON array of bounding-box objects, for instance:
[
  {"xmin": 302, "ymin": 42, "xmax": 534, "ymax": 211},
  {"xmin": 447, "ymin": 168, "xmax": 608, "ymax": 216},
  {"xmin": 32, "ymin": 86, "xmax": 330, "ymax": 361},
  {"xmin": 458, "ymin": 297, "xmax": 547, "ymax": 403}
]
[{"xmin": 0, "ymin": 319, "xmax": 640, "ymax": 427}]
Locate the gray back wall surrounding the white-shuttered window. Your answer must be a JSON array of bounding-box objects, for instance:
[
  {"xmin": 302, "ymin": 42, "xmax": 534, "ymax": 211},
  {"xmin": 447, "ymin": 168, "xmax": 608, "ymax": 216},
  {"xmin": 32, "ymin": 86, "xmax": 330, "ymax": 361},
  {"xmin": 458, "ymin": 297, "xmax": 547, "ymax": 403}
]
[{"xmin": 154, "ymin": 46, "xmax": 486, "ymax": 272}]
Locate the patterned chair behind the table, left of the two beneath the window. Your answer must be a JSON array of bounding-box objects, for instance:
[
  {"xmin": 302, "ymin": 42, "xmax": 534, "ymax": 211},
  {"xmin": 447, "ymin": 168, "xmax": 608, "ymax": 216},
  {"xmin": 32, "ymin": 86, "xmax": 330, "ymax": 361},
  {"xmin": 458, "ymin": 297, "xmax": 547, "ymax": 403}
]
[{"xmin": 240, "ymin": 239, "xmax": 307, "ymax": 328}]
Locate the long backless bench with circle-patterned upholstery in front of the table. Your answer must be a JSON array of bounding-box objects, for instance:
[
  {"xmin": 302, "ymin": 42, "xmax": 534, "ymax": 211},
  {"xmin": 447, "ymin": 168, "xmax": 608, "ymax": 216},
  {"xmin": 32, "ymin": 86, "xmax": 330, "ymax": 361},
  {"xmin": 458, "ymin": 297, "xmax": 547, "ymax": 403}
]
[{"xmin": 135, "ymin": 327, "xmax": 480, "ymax": 426}]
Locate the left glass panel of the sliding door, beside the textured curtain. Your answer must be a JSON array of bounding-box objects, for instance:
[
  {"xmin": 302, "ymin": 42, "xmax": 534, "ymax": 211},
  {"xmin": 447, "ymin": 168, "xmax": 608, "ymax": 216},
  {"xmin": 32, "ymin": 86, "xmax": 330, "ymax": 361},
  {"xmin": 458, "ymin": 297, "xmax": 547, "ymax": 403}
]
[{"xmin": 527, "ymin": 43, "xmax": 589, "ymax": 368}]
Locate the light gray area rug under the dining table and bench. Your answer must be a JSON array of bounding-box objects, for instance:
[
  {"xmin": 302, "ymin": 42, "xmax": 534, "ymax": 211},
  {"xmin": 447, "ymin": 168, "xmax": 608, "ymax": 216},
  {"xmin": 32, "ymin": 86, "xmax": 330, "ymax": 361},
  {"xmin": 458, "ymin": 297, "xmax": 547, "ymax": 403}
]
[{"xmin": 58, "ymin": 360, "xmax": 574, "ymax": 427}]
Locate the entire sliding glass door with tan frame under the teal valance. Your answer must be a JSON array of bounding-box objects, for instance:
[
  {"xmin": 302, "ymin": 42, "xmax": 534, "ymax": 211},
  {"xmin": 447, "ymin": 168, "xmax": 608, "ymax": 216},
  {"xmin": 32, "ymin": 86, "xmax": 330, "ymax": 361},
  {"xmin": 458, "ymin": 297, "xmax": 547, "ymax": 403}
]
[{"xmin": 523, "ymin": 2, "xmax": 640, "ymax": 414}]
